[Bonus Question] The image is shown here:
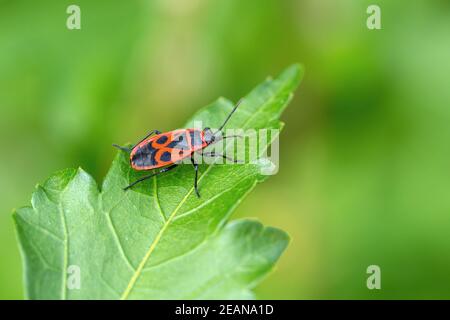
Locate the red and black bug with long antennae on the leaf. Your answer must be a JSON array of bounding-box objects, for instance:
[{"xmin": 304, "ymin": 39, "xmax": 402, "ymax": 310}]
[{"xmin": 113, "ymin": 100, "xmax": 242, "ymax": 198}]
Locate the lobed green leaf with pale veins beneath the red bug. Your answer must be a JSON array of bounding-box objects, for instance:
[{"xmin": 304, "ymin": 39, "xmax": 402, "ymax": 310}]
[{"xmin": 14, "ymin": 65, "xmax": 302, "ymax": 299}]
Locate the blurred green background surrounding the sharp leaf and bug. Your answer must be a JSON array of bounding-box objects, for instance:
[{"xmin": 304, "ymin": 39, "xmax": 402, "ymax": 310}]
[{"xmin": 0, "ymin": 0, "xmax": 450, "ymax": 299}]
